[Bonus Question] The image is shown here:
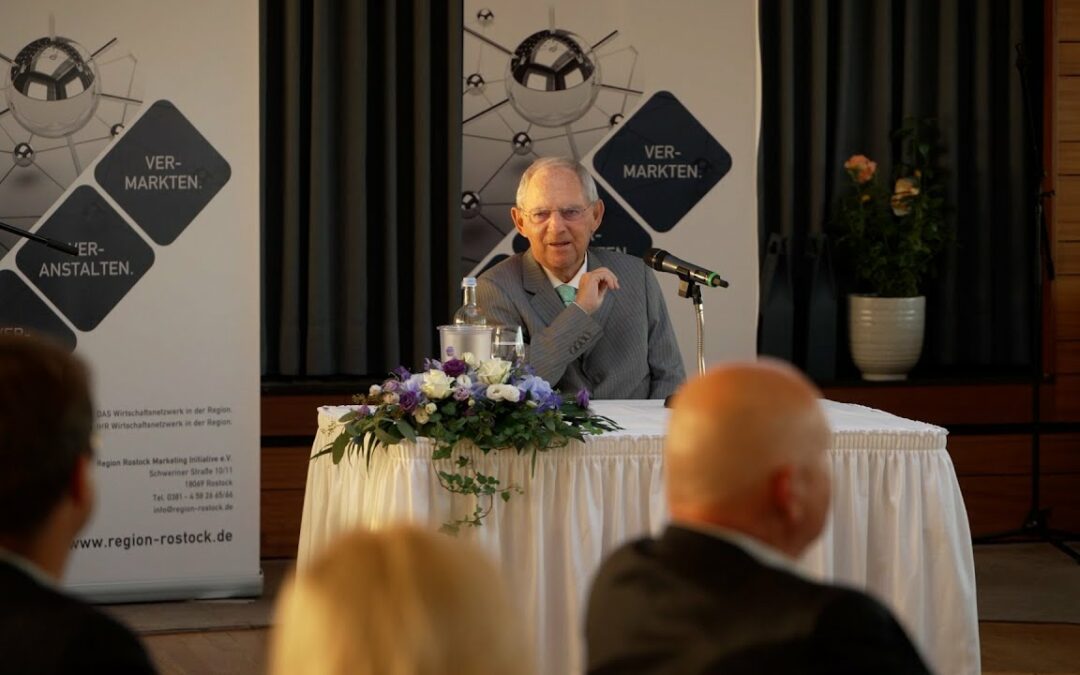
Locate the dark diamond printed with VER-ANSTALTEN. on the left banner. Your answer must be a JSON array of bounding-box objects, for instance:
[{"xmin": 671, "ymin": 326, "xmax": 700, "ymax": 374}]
[{"xmin": 15, "ymin": 186, "xmax": 153, "ymax": 330}]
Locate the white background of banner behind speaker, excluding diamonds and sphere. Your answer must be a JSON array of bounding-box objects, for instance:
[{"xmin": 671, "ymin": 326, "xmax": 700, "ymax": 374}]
[{"xmin": 462, "ymin": 0, "xmax": 760, "ymax": 375}]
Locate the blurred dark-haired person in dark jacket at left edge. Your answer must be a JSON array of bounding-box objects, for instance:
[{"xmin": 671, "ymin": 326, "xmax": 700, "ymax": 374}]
[{"xmin": 0, "ymin": 336, "xmax": 154, "ymax": 674}]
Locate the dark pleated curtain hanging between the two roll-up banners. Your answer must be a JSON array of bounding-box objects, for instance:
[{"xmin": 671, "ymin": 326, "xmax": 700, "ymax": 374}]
[{"xmin": 261, "ymin": 0, "xmax": 461, "ymax": 376}]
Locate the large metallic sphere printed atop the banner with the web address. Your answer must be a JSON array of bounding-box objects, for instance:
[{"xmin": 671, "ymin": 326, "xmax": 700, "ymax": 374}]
[{"xmin": 8, "ymin": 36, "xmax": 100, "ymax": 138}]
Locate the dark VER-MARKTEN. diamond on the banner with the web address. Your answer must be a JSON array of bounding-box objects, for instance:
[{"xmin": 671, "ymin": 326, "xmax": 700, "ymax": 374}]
[{"xmin": 94, "ymin": 100, "xmax": 232, "ymax": 245}]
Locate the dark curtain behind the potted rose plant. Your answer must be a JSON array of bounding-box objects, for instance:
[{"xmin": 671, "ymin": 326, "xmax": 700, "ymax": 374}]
[{"xmin": 758, "ymin": 0, "xmax": 1042, "ymax": 381}]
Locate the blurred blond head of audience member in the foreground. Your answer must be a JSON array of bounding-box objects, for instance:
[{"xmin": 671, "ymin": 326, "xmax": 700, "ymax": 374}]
[{"xmin": 270, "ymin": 526, "xmax": 536, "ymax": 675}]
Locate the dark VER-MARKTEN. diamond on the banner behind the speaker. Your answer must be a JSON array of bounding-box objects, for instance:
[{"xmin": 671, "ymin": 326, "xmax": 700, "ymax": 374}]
[{"xmin": 593, "ymin": 92, "xmax": 731, "ymax": 232}]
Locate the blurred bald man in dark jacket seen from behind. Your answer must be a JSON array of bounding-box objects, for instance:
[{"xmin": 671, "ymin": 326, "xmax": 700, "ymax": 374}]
[{"xmin": 585, "ymin": 362, "xmax": 928, "ymax": 675}]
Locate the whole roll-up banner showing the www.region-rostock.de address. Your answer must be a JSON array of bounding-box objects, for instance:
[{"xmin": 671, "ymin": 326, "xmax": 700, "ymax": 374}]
[{"xmin": 0, "ymin": 0, "xmax": 261, "ymax": 602}]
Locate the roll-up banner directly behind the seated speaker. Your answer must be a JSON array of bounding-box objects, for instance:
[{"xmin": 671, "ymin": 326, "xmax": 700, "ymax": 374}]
[{"xmin": 461, "ymin": 0, "xmax": 760, "ymax": 374}]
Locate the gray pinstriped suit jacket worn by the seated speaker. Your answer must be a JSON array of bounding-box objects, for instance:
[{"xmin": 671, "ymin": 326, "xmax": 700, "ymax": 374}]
[{"xmin": 476, "ymin": 248, "xmax": 686, "ymax": 399}]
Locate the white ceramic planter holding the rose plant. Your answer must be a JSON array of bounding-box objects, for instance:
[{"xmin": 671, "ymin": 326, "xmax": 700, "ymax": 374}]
[{"xmin": 848, "ymin": 295, "xmax": 927, "ymax": 381}]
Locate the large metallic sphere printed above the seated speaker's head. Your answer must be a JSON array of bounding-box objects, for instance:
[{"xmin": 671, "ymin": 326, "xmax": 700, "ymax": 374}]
[{"xmin": 507, "ymin": 29, "xmax": 602, "ymax": 126}]
